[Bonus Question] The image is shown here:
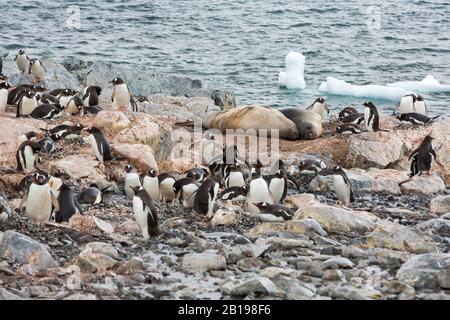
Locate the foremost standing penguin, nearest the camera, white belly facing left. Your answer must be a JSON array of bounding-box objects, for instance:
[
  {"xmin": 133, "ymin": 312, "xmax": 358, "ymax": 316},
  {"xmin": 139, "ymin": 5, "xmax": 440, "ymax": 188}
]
[{"xmin": 129, "ymin": 186, "xmax": 159, "ymax": 240}]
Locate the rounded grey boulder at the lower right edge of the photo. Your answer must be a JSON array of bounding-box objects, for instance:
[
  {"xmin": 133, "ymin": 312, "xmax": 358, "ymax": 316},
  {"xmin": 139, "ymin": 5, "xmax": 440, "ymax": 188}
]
[{"xmin": 397, "ymin": 253, "xmax": 450, "ymax": 290}]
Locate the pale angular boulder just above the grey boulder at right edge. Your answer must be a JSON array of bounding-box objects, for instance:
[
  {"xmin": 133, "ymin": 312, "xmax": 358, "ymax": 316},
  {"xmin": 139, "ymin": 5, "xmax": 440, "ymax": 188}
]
[{"xmin": 366, "ymin": 221, "xmax": 437, "ymax": 254}]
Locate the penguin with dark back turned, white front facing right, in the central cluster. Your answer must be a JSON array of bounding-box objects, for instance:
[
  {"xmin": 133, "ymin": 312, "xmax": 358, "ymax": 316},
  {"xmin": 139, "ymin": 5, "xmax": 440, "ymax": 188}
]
[{"xmin": 194, "ymin": 176, "xmax": 220, "ymax": 218}]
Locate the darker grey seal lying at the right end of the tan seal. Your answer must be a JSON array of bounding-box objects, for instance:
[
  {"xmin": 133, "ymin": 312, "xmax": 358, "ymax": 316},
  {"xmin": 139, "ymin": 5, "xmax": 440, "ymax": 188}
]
[{"xmin": 279, "ymin": 108, "xmax": 323, "ymax": 140}]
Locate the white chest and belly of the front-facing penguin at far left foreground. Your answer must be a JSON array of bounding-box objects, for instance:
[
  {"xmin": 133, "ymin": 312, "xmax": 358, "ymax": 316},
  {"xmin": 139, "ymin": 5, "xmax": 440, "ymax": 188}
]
[{"xmin": 25, "ymin": 183, "xmax": 52, "ymax": 223}]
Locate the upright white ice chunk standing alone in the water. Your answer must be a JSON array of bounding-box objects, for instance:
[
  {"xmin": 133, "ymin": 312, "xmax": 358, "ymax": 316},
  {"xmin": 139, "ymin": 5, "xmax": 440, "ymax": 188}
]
[{"xmin": 278, "ymin": 51, "xmax": 306, "ymax": 89}]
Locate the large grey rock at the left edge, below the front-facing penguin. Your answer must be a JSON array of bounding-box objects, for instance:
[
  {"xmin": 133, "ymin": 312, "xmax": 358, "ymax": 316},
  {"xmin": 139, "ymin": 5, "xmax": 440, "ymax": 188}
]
[{"xmin": 0, "ymin": 230, "xmax": 58, "ymax": 269}]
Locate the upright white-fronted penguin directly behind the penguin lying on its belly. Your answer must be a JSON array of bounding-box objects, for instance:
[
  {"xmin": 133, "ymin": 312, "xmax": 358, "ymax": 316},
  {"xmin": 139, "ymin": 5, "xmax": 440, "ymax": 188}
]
[{"xmin": 246, "ymin": 160, "xmax": 274, "ymax": 214}]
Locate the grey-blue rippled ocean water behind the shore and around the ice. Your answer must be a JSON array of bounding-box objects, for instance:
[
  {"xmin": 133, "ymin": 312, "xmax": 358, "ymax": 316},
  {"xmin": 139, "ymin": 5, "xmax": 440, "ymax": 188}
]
[{"xmin": 0, "ymin": 0, "xmax": 450, "ymax": 115}]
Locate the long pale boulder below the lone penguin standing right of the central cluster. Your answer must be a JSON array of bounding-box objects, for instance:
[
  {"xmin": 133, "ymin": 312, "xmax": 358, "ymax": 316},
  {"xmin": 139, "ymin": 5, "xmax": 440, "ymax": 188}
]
[{"xmin": 300, "ymin": 205, "xmax": 376, "ymax": 234}]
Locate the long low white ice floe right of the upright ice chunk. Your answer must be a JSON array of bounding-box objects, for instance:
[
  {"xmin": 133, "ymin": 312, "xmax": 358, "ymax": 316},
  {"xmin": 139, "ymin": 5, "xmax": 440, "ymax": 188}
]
[{"xmin": 319, "ymin": 77, "xmax": 412, "ymax": 101}]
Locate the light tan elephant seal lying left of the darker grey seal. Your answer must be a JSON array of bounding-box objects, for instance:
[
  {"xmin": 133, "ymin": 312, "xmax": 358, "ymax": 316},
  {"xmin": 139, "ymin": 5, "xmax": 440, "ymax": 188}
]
[{"xmin": 203, "ymin": 105, "xmax": 298, "ymax": 140}]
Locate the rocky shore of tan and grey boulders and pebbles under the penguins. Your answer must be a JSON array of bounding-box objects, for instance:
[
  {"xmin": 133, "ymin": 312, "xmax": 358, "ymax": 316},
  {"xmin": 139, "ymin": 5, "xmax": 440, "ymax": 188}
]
[{"xmin": 0, "ymin": 60, "xmax": 450, "ymax": 300}]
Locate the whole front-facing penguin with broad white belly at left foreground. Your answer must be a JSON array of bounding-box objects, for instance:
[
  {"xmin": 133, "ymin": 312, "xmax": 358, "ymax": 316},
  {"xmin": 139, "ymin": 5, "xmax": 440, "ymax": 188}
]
[{"xmin": 25, "ymin": 172, "xmax": 54, "ymax": 224}]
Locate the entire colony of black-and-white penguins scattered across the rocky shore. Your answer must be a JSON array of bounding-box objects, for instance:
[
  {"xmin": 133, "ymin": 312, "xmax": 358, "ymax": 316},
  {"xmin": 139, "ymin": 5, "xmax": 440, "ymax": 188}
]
[{"xmin": 0, "ymin": 50, "xmax": 437, "ymax": 240}]
